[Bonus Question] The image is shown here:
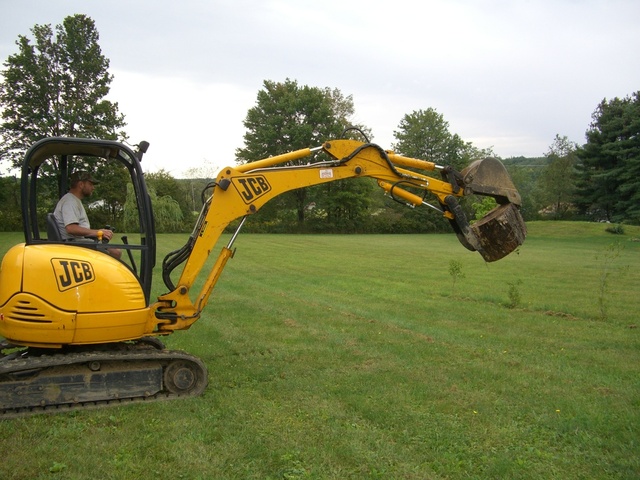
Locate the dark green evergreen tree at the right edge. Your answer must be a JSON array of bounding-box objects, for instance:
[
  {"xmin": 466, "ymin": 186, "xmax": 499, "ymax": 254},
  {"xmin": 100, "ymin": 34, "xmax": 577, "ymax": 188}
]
[{"xmin": 577, "ymin": 91, "xmax": 640, "ymax": 222}]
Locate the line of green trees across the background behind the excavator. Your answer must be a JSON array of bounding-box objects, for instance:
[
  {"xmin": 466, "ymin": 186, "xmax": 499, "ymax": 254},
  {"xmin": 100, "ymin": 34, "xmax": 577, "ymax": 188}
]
[{"xmin": 0, "ymin": 15, "xmax": 640, "ymax": 233}]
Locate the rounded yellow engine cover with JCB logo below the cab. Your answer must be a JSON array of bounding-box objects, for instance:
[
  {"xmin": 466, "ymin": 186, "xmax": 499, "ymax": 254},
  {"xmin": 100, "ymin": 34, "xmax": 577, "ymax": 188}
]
[{"xmin": 0, "ymin": 244, "xmax": 149, "ymax": 347}]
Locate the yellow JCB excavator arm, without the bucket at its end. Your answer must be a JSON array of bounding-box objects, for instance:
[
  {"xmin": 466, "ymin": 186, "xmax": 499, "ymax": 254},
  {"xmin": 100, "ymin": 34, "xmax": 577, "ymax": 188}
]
[{"xmin": 150, "ymin": 140, "xmax": 463, "ymax": 334}]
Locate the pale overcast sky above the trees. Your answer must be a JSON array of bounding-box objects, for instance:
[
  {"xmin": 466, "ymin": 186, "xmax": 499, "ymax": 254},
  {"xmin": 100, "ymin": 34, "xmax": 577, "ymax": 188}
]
[{"xmin": 0, "ymin": 0, "xmax": 640, "ymax": 177}]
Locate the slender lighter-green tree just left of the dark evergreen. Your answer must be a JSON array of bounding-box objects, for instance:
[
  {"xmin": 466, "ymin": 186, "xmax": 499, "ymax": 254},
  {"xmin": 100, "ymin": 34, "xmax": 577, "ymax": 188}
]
[{"xmin": 540, "ymin": 134, "xmax": 578, "ymax": 220}]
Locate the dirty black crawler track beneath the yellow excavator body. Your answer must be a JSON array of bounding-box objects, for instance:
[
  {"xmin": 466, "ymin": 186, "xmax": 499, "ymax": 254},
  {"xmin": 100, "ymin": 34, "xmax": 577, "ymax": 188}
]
[{"xmin": 0, "ymin": 337, "xmax": 207, "ymax": 419}]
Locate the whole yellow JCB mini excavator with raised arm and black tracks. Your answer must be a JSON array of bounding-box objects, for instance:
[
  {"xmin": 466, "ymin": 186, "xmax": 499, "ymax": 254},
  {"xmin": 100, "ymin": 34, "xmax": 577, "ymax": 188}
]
[{"xmin": 0, "ymin": 137, "xmax": 526, "ymax": 418}]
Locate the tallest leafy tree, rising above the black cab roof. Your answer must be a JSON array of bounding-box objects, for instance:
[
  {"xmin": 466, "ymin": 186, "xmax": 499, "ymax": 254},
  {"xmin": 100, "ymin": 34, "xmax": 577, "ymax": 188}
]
[{"xmin": 0, "ymin": 15, "xmax": 125, "ymax": 167}]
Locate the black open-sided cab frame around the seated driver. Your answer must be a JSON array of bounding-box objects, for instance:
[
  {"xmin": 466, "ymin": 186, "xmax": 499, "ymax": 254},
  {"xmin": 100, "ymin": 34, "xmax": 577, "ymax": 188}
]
[{"xmin": 20, "ymin": 137, "xmax": 156, "ymax": 298}]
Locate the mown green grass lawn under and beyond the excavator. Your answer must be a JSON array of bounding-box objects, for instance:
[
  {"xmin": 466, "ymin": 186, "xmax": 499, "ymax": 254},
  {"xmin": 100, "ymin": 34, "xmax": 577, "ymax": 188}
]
[{"xmin": 0, "ymin": 222, "xmax": 640, "ymax": 479}]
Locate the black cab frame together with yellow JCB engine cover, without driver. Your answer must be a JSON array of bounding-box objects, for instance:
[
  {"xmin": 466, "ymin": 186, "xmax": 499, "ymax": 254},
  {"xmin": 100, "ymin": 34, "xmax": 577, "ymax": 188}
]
[{"xmin": 0, "ymin": 137, "xmax": 156, "ymax": 348}]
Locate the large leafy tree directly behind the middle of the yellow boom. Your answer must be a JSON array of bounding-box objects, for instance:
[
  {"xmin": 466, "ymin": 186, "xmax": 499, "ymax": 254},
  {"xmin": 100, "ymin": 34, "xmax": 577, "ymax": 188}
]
[{"xmin": 236, "ymin": 79, "xmax": 372, "ymax": 229}]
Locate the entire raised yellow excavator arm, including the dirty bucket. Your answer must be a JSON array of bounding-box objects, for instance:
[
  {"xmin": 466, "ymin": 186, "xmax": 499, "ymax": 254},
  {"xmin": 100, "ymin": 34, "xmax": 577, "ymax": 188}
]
[{"xmin": 154, "ymin": 139, "xmax": 526, "ymax": 333}]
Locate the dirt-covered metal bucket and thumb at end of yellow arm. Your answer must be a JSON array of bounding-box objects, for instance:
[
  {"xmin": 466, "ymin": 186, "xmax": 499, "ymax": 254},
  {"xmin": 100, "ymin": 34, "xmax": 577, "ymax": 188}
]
[{"xmin": 445, "ymin": 158, "xmax": 527, "ymax": 262}]
